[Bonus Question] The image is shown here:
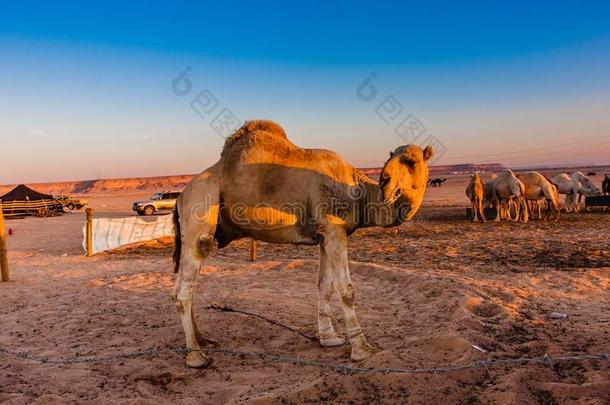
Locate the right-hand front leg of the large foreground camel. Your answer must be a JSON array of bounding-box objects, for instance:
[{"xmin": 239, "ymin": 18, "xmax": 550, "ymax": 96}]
[{"xmin": 322, "ymin": 225, "xmax": 377, "ymax": 361}]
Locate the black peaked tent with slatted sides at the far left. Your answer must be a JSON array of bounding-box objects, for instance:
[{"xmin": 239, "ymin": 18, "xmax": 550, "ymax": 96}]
[{"xmin": 0, "ymin": 184, "xmax": 64, "ymax": 218}]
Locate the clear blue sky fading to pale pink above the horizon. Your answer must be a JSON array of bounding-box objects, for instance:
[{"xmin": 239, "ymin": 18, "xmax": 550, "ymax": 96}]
[{"xmin": 0, "ymin": 1, "xmax": 610, "ymax": 183}]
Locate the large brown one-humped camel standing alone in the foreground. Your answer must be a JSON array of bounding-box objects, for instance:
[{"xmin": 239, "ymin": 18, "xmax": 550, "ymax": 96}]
[{"xmin": 174, "ymin": 121, "xmax": 432, "ymax": 367}]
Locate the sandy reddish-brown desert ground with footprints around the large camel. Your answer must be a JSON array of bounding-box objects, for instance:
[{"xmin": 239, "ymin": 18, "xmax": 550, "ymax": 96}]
[{"xmin": 0, "ymin": 176, "xmax": 610, "ymax": 404}]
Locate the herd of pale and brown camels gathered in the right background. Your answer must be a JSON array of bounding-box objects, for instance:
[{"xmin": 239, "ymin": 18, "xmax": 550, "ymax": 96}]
[{"xmin": 466, "ymin": 169, "xmax": 610, "ymax": 222}]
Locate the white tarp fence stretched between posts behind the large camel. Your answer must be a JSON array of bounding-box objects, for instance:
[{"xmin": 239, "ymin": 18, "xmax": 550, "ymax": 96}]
[{"xmin": 83, "ymin": 215, "xmax": 174, "ymax": 254}]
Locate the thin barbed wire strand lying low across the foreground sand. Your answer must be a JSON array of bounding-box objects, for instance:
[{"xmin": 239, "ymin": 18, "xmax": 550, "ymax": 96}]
[{"xmin": 0, "ymin": 346, "xmax": 610, "ymax": 375}]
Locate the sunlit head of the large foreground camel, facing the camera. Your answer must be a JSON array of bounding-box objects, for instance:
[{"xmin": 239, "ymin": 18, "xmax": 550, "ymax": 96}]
[{"xmin": 379, "ymin": 145, "xmax": 432, "ymax": 222}]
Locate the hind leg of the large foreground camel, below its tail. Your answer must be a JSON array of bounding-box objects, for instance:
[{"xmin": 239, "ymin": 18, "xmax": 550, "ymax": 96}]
[{"xmin": 173, "ymin": 167, "xmax": 220, "ymax": 368}]
